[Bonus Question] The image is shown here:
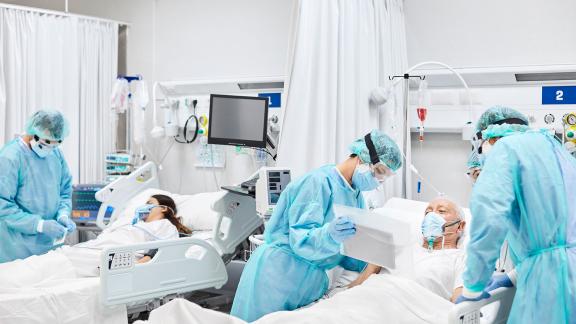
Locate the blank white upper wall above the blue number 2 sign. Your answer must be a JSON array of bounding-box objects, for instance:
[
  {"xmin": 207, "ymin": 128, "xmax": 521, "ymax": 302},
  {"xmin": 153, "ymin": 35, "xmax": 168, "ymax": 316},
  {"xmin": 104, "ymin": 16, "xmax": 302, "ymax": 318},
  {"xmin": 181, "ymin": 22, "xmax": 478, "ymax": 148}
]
[{"xmin": 405, "ymin": 0, "xmax": 576, "ymax": 67}]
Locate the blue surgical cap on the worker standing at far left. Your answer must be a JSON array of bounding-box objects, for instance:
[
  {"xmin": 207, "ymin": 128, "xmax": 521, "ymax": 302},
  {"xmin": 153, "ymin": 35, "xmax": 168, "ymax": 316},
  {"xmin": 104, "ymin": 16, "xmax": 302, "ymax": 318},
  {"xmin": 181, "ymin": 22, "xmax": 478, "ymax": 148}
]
[{"xmin": 26, "ymin": 110, "xmax": 69, "ymax": 141}]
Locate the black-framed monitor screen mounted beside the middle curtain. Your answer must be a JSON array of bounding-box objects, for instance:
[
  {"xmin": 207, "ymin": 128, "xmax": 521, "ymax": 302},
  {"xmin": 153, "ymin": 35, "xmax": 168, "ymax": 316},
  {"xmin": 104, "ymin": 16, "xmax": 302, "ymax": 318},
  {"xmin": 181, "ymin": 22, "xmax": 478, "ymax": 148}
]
[{"xmin": 208, "ymin": 94, "xmax": 268, "ymax": 148}]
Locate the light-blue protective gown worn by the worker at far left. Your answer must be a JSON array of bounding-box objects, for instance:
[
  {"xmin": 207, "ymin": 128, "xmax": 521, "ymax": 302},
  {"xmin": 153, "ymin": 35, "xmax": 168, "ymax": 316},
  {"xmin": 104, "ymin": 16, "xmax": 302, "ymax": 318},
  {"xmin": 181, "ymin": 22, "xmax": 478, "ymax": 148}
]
[{"xmin": 0, "ymin": 138, "xmax": 72, "ymax": 263}]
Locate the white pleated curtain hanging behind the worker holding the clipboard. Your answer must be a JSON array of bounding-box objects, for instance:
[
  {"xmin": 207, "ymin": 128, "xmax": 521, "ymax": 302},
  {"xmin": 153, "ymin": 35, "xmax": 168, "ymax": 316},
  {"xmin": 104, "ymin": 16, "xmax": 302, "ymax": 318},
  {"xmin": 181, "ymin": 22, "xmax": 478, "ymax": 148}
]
[{"xmin": 277, "ymin": 0, "xmax": 407, "ymax": 204}]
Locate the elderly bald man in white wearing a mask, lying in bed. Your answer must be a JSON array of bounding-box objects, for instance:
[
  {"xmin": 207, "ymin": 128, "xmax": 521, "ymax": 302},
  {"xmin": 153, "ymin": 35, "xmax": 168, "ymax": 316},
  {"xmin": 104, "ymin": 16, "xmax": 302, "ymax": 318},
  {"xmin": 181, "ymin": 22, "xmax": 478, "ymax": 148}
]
[{"xmin": 342, "ymin": 198, "xmax": 466, "ymax": 302}]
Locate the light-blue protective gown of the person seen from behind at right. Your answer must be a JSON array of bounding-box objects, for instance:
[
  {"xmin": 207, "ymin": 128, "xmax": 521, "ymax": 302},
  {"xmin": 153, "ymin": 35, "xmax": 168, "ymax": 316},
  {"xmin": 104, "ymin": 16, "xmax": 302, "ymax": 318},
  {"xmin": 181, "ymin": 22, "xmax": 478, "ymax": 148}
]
[{"xmin": 464, "ymin": 132, "xmax": 576, "ymax": 323}]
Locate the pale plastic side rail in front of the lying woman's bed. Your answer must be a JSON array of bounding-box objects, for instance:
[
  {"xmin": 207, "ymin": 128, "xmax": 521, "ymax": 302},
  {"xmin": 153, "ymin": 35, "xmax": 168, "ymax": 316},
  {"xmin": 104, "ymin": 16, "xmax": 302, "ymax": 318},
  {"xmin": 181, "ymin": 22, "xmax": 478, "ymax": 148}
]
[{"xmin": 100, "ymin": 238, "xmax": 228, "ymax": 305}]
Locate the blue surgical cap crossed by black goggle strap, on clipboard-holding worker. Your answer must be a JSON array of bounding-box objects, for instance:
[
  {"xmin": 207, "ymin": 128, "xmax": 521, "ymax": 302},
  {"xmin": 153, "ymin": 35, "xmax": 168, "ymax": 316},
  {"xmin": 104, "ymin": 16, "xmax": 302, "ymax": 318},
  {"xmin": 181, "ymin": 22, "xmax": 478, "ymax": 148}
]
[{"xmin": 349, "ymin": 130, "xmax": 402, "ymax": 171}]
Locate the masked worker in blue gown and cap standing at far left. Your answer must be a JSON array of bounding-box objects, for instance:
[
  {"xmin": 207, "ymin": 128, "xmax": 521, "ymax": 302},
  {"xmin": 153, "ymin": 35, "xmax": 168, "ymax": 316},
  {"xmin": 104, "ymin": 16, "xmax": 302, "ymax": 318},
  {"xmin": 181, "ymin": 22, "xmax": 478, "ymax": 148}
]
[{"xmin": 0, "ymin": 110, "xmax": 76, "ymax": 263}]
